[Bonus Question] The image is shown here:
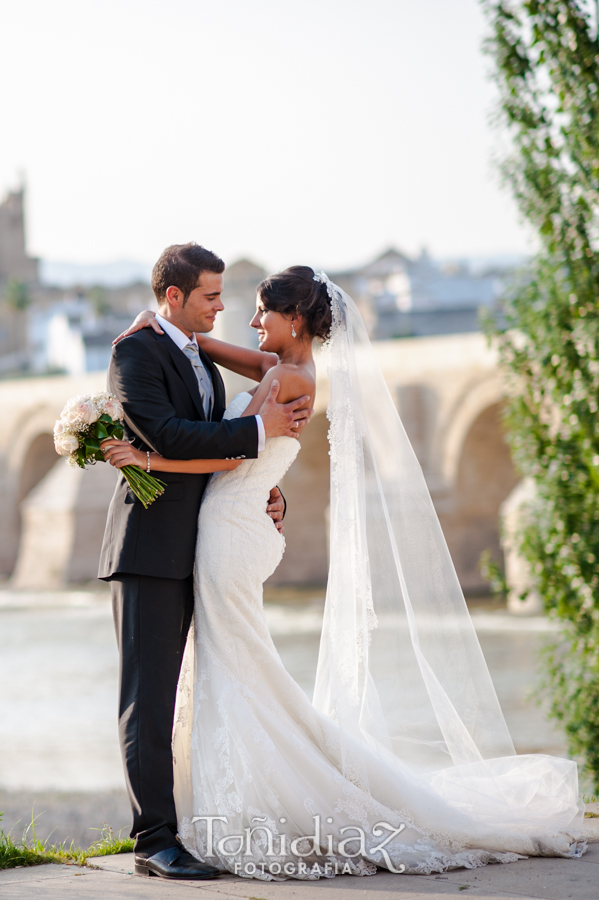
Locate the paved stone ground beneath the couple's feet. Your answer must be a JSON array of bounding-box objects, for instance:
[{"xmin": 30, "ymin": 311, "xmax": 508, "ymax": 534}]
[{"xmin": 0, "ymin": 819, "xmax": 599, "ymax": 900}]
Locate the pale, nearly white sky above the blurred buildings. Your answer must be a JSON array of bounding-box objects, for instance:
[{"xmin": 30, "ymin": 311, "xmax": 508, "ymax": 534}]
[{"xmin": 0, "ymin": 0, "xmax": 531, "ymax": 270}]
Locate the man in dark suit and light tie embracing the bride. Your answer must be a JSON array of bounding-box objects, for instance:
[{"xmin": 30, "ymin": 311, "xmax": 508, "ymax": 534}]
[{"xmin": 98, "ymin": 243, "xmax": 310, "ymax": 879}]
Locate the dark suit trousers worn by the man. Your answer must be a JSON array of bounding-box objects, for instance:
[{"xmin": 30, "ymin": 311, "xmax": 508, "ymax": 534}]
[{"xmin": 110, "ymin": 573, "xmax": 193, "ymax": 856}]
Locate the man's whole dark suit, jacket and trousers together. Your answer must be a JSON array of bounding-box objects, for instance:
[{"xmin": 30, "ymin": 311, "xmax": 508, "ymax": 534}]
[{"xmin": 99, "ymin": 328, "xmax": 258, "ymax": 856}]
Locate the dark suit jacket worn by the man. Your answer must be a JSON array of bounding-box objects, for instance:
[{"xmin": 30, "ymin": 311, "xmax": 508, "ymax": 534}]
[{"xmin": 98, "ymin": 328, "xmax": 258, "ymax": 579}]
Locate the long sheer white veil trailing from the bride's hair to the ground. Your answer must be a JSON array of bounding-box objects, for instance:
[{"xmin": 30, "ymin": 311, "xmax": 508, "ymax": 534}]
[{"xmin": 313, "ymin": 273, "xmax": 583, "ymax": 852}]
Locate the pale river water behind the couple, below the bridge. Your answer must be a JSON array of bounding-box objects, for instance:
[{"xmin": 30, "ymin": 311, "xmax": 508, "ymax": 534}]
[{"xmin": 0, "ymin": 589, "xmax": 566, "ymax": 792}]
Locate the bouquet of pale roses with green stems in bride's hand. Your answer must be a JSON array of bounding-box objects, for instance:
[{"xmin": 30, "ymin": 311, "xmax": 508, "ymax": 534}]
[{"xmin": 54, "ymin": 391, "xmax": 166, "ymax": 509}]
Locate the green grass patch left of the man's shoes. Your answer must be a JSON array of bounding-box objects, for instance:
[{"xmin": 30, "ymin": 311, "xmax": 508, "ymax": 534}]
[{"xmin": 0, "ymin": 813, "xmax": 133, "ymax": 869}]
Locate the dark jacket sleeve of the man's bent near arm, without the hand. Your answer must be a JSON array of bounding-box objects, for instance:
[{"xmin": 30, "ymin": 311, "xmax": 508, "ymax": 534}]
[{"xmin": 108, "ymin": 338, "xmax": 258, "ymax": 459}]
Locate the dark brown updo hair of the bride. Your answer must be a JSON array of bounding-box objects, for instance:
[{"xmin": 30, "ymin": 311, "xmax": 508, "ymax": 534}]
[{"xmin": 258, "ymin": 266, "xmax": 332, "ymax": 341}]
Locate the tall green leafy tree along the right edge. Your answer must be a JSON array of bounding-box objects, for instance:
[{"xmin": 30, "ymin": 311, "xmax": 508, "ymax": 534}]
[{"xmin": 483, "ymin": 0, "xmax": 599, "ymax": 786}]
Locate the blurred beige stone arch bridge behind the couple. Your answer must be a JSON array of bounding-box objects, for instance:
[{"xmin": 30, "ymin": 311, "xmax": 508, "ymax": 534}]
[{"xmin": 0, "ymin": 334, "xmax": 518, "ymax": 593}]
